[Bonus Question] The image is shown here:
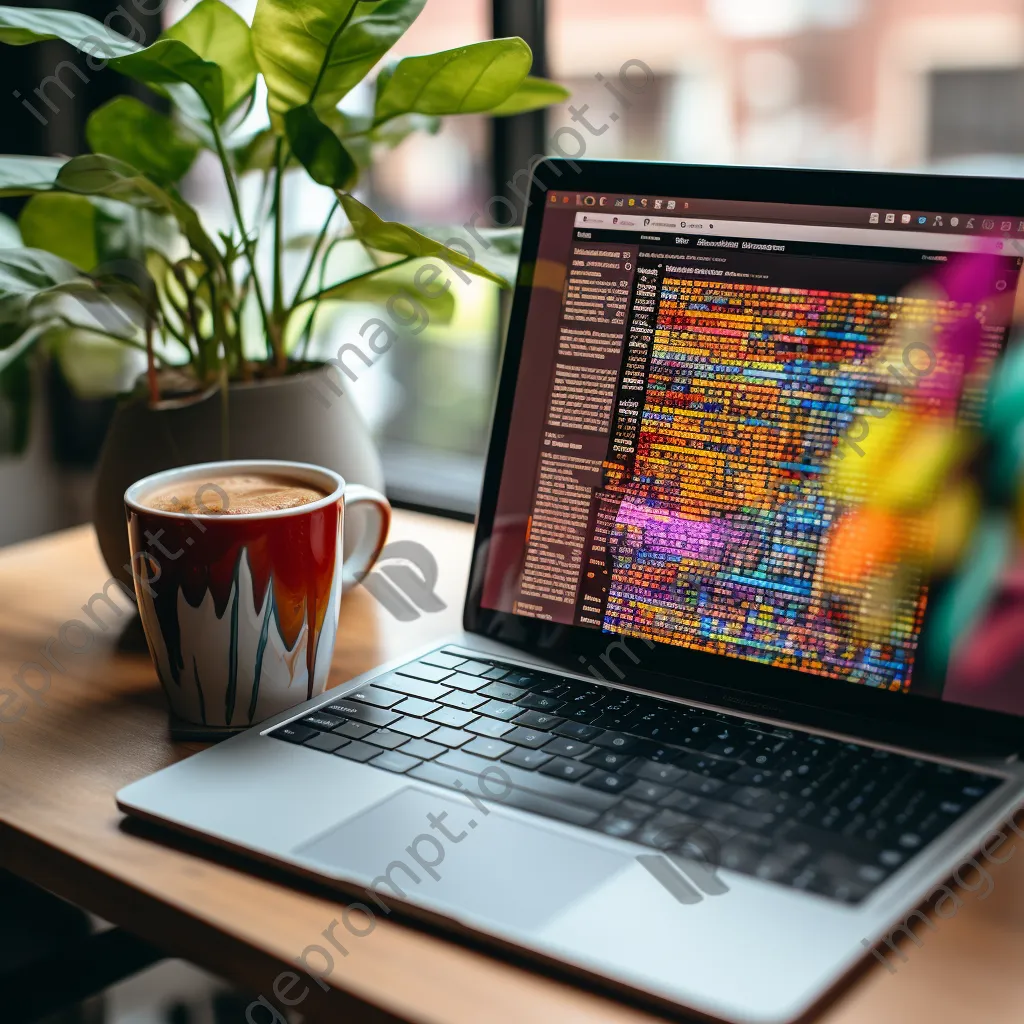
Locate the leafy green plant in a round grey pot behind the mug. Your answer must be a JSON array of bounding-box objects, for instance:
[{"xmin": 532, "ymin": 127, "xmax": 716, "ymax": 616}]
[{"xmin": 0, "ymin": 0, "xmax": 567, "ymax": 575}]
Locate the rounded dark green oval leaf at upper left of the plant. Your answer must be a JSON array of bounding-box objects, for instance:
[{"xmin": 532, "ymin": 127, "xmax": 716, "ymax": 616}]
[{"xmin": 85, "ymin": 96, "xmax": 200, "ymax": 182}]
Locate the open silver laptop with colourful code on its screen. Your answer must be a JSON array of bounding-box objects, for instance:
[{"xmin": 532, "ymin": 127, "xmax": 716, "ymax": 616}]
[{"xmin": 118, "ymin": 160, "xmax": 1024, "ymax": 1024}]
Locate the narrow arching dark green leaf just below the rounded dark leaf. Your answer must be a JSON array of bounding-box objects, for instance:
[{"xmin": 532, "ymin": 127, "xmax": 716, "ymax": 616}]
[{"xmin": 56, "ymin": 156, "xmax": 220, "ymax": 267}]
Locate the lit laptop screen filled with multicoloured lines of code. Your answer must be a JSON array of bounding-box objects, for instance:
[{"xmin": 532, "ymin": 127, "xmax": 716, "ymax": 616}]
[{"xmin": 481, "ymin": 189, "xmax": 1024, "ymax": 713}]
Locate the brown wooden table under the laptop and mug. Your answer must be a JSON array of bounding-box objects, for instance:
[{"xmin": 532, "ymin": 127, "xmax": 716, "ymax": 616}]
[{"xmin": 6, "ymin": 513, "xmax": 1024, "ymax": 1024}]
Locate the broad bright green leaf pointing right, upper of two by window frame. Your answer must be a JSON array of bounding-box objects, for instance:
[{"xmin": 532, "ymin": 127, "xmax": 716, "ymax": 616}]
[{"xmin": 374, "ymin": 37, "xmax": 534, "ymax": 122}]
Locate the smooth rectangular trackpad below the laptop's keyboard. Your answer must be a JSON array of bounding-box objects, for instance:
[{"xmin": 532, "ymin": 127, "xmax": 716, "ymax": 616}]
[{"xmin": 294, "ymin": 788, "xmax": 631, "ymax": 929}]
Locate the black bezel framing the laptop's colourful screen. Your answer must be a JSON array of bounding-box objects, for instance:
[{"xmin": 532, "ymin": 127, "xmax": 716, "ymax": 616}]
[{"xmin": 463, "ymin": 159, "xmax": 1024, "ymax": 741}]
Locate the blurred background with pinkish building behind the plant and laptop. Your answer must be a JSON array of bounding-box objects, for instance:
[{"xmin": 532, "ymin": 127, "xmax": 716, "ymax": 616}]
[{"xmin": 6, "ymin": 0, "xmax": 1024, "ymax": 544}]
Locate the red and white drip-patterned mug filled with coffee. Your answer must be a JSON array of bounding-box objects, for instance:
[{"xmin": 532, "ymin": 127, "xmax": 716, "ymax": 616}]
[{"xmin": 125, "ymin": 460, "xmax": 391, "ymax": 729}]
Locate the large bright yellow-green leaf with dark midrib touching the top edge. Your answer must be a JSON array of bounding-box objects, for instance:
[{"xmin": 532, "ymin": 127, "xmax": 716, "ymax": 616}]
[{"xmin": 252, "ymin": 0, "xmax": 426, "ymax": 132}]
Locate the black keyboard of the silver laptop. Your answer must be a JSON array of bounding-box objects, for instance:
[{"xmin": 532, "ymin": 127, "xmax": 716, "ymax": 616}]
[{"xmin": 270, "ymin": 648, "xmax": 1000, "ymax": 903}]
